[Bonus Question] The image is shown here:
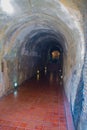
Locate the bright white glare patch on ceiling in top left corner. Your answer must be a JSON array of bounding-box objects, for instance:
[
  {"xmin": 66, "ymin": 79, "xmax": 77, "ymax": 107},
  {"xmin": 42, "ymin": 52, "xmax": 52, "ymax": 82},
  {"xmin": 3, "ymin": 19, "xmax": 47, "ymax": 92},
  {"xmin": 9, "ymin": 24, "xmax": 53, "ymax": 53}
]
[{"xmin": 1, "ymin": 0, "xmax": 14, "ymax": 14}]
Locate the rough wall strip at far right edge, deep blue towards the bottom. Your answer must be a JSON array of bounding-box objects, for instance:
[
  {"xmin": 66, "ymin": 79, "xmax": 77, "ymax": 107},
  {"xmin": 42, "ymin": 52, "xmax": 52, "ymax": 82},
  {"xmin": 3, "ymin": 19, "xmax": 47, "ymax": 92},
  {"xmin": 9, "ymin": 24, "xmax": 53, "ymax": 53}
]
[{"xmin": 61, "ymin": 0, "xmax": 87, "ymax": 130}]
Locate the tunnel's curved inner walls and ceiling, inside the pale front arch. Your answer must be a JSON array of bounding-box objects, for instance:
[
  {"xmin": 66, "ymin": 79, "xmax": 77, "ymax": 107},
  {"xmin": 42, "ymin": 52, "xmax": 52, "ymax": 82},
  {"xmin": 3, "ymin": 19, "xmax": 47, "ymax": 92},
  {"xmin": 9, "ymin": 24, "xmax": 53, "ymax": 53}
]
[{"xmin": 1, "ymin": 6, "xmax": 84, "ymax": 108}]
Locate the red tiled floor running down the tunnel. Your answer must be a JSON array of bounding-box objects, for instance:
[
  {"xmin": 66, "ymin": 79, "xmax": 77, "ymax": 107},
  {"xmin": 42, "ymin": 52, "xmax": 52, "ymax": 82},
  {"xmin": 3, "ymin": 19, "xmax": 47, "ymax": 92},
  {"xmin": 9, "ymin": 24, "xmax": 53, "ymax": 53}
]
[{"xmin": 0, "ymin": 70, "xmax": 73, "ymax": 130}]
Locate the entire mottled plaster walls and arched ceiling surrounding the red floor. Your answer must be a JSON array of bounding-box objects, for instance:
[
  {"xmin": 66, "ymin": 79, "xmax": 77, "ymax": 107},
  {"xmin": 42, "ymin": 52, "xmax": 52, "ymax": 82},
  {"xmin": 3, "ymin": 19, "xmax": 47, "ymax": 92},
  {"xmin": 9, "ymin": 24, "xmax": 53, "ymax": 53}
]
[{"xmin": 0, "ymin": 0, "xmax": 87, "ymax": 130}]
